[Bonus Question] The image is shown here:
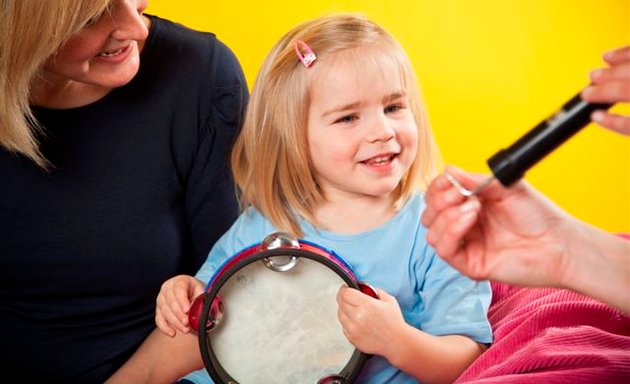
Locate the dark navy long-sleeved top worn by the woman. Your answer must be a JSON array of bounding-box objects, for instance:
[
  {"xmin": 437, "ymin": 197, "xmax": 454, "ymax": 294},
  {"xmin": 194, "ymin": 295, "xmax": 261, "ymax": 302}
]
[{"xmin": 0, "ymin": 16, "xmax": 247, "ymax": 383}]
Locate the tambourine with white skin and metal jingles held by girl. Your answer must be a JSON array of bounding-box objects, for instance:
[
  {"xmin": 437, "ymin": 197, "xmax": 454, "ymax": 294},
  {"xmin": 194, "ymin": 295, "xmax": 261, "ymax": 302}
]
[{"xmin": 189, "ymin": 233, "xmax": 377, "ymax": 384}]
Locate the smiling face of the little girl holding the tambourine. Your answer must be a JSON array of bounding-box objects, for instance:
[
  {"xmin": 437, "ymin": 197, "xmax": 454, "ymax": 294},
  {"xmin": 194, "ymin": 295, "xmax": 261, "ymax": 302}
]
[{"xmin": 307, "ymin": 47, "xmax": 418, "ymax": 203}]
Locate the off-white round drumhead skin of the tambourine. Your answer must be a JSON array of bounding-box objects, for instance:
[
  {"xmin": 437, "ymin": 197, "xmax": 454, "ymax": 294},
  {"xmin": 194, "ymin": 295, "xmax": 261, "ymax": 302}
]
[{"xmin": 208, "ymin": 259, "xmax": 354, "ymax": 384}]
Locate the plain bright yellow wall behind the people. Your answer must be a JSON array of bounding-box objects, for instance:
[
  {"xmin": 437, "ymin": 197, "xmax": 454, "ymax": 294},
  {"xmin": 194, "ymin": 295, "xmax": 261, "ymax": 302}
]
[{"xmin": 147, "ymin": 0, "xmax": 630, "ymax": 232}]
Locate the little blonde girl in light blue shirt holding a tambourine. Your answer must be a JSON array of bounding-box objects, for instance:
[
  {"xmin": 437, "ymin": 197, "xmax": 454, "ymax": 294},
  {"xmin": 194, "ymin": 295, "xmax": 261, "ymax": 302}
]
[{"xmin": 112, "ymin": 15, "xmax": 492, "ymax": 383}]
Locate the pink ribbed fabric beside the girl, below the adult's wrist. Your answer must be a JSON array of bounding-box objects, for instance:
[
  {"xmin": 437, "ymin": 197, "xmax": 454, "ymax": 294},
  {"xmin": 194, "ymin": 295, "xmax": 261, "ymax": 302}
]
[{"xmin": 456, "ymin": 283, "xmax": 630, "ymax": 384}]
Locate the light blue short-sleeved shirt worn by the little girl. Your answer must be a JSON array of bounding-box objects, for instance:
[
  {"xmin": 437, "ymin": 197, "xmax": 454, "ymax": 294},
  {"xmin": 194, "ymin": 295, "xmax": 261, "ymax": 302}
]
[{"xmin": 186, "ymin": 193, "xmax": 492, "ymax": 384}]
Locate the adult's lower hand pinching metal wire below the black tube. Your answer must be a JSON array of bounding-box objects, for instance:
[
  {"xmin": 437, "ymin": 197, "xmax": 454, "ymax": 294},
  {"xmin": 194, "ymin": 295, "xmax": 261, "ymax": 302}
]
[{"xmin": 422, "ymin": 167, "xmax": 573, "ymax": 286}]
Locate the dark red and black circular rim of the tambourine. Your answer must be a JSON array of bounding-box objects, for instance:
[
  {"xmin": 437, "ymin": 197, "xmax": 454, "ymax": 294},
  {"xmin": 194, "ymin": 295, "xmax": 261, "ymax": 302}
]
[{"xmin": 197, "ymin": 243, "xmax": 368, "ymax": 383}]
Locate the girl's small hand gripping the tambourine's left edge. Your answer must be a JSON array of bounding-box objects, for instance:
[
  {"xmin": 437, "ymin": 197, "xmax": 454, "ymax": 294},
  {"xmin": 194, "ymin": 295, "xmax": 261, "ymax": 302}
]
[{"xmin": 155, "ymin": 275, "xmax": 204, "ymax": 337}]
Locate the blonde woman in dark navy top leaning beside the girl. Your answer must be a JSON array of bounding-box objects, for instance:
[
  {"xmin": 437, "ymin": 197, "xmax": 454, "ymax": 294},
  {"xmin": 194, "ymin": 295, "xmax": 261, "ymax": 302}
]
[{"xmin": 0, "ymin": 0, "xmax": 247, "ymax": 383}]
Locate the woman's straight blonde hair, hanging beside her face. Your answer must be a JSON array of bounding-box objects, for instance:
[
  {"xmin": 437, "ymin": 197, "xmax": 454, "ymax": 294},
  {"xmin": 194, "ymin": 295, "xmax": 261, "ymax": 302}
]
[{"xmin": 0, "ymin": 0, "xmax": 110, "ymax": 168}]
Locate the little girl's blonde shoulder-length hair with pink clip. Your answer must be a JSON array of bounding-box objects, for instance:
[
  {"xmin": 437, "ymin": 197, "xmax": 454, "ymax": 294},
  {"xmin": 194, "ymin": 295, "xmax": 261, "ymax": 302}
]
[{"xmin": 232, "ymin": 14, "xmax": 437, "ymax": 236}]
